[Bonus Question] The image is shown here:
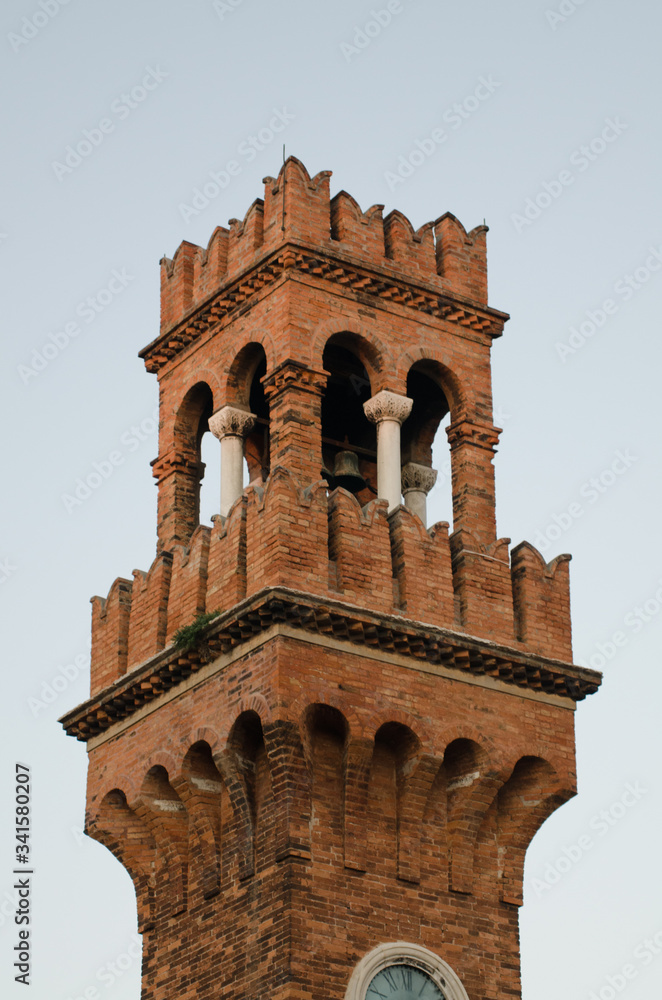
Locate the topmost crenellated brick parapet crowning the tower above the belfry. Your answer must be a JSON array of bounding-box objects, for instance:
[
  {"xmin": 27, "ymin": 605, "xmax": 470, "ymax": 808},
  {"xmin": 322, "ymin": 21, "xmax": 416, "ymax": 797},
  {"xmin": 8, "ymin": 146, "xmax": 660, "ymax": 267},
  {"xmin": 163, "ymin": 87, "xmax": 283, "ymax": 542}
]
[{"xmin": 161, "ymin": 156, "xmax": 498, "ymax": 340}]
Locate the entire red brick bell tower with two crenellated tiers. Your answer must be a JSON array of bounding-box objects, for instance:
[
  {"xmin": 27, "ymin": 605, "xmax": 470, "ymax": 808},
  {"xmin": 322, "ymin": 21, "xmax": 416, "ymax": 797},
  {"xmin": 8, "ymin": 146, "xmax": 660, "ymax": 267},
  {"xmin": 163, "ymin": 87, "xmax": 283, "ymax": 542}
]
[{"xmin": 62, "ymin": 157, "xmax": 600, "ymax": 1000}]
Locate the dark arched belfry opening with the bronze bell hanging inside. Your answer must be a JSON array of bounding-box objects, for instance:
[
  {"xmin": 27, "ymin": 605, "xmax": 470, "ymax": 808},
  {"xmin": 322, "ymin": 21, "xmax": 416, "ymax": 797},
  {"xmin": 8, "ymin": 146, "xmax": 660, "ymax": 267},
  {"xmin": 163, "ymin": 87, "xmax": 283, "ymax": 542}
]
[{"xmin": 321, "ymin": 334, "xmax": 377, "ymax": 505}]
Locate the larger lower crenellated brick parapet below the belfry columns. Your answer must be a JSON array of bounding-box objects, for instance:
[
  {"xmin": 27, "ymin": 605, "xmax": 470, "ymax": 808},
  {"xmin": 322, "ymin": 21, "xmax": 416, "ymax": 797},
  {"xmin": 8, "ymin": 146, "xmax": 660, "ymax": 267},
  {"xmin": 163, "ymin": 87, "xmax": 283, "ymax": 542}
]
[{"xmin": 84, "ymin": 467, "xmax": 592, "ymax": 694}]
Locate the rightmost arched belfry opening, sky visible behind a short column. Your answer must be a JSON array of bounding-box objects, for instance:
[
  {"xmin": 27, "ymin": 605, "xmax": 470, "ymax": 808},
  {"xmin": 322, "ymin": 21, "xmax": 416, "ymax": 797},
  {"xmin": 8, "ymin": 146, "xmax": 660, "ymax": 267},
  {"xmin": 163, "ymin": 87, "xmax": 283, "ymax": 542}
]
[{"xmin": 402, "ymin": 361, "xmax": 453, "ymax": 524}]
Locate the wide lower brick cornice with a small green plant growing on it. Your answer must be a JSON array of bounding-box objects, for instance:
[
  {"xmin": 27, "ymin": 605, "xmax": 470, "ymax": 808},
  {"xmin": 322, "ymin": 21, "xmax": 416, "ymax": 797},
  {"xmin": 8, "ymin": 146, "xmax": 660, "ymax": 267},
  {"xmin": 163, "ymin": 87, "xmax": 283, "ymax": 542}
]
[{"xmin": 60, "ymin": 587, "xmax": 602, "ymax": 742}]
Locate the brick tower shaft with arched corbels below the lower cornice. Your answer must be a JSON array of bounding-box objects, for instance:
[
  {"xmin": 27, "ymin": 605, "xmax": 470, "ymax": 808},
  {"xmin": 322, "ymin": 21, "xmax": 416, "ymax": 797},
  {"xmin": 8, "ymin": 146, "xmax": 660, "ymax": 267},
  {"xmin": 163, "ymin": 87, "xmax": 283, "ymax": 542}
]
[{"xmin": 88, "ymin": 637, "xmax": 575, "ymax": 1000}]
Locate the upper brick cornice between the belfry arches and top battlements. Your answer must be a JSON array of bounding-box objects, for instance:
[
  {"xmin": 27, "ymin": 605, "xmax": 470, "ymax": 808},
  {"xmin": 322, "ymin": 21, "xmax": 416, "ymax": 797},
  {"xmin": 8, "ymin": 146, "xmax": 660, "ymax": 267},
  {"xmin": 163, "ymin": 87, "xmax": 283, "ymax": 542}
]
[{"xmin": 139, "ymin": 244, "xmax": 509, "ymax": 372}]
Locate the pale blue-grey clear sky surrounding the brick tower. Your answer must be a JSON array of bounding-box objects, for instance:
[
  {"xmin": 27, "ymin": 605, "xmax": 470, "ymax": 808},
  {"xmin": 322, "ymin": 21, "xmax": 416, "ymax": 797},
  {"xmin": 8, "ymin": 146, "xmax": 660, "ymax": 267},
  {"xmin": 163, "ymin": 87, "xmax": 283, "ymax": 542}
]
[{"xmin": 0, "ymin": 0, "xmax": 662, "ymax": 1000}]
